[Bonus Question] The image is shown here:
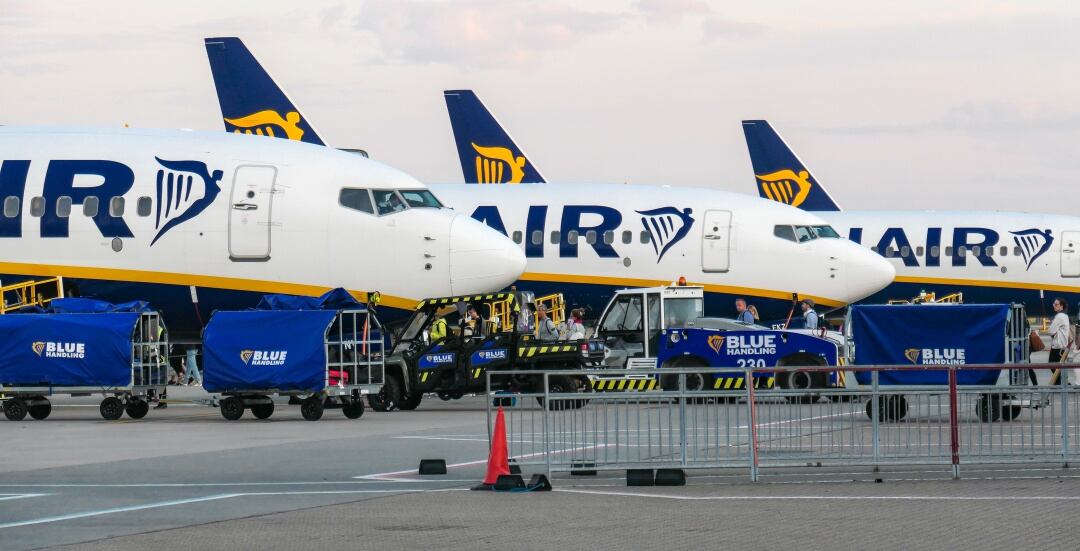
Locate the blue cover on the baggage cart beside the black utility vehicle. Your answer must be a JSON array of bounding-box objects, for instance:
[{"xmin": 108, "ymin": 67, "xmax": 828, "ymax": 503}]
[{"xmin": 203, "ymin": 310, "xmax": 337, "ymax": 392}]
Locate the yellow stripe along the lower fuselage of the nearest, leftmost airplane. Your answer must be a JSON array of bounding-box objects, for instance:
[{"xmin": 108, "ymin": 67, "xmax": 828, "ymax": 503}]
[{"xmin": 0, "ymin": 263, "xmax": 419, "ymax": 310}]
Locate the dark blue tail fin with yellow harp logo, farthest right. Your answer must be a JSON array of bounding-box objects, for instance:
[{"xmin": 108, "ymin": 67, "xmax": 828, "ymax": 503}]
[{"xmin": 743, "ymin": 121, "xmax": 840, "ymax": 211}]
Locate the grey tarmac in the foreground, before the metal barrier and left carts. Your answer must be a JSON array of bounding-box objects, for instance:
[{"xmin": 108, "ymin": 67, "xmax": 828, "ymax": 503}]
[{"xmin": 0, "ymin": 389, "xmax": 1080, "ymax": 550}]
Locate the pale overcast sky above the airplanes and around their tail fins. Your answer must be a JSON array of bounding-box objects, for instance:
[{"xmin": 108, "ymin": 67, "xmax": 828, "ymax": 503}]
[{"xmin": 0, "ymin": 0, "xmax": 1080, "ymax": 214}]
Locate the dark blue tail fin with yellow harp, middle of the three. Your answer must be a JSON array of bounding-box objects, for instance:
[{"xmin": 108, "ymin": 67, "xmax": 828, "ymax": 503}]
[{"xmin": 443, "ymin": 90, "xmax": 544, "ymax": 184}]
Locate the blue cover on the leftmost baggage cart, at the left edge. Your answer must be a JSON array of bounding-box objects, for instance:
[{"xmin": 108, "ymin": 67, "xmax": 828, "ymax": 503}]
[{"xmin": 0, "ymin": 313, "xmax": 139, "ymax": 388}]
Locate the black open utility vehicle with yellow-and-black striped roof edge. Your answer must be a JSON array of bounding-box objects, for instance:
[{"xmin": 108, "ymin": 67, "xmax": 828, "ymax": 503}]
[{"xmin": 382, "ymin": 292, "xmax": 600, "ymax": 409}]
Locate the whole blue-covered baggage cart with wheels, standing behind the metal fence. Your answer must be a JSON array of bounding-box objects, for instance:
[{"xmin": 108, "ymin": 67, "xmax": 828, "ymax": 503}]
[{"xmin": 845, "ymin": 304, "xmax": 1044, "ymax": 421}]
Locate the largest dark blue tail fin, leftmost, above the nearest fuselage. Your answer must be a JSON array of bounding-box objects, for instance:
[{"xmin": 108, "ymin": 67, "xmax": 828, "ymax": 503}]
[{"xmin": 204, "ymin": 37, "xmax": 326, "ymax": 146}]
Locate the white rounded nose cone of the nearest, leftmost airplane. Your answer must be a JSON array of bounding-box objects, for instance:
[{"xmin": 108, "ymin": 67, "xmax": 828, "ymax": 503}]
[{"xmin": 450, "ymin": 214, "xmax": 525, "ymax": 295}]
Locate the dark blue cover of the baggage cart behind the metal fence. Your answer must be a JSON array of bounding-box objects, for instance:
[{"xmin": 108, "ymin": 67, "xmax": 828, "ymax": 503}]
[{"xmin": 851, "ymin": 305, "xmax": 1009, "ymax": 385}]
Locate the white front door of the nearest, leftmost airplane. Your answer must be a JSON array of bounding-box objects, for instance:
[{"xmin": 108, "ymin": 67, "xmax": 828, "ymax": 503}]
[{"xmin": 229, "ymin": 166, "xmax": 278, "ymax": 261}]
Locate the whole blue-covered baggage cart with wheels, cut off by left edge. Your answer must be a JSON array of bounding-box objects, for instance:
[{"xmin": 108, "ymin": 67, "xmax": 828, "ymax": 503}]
[{"xmin": 0, "ymin": 298, "xmax": 168, "ymax": 421}]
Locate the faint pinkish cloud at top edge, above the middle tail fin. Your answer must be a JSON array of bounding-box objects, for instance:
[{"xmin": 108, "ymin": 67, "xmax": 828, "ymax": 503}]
[{"xmin": 354, "ymin": 0, "xmax": 629, "ymax": 67}]
